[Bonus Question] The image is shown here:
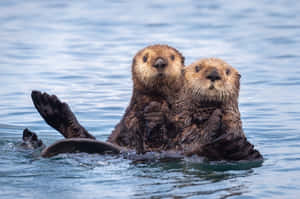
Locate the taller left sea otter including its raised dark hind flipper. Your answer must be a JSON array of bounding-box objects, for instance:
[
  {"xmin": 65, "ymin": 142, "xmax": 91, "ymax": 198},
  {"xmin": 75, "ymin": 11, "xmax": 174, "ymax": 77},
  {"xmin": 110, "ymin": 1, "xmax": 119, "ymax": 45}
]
[{"xmin": 31, "ymin": 45, "xmax": 184, "ymax": 153}]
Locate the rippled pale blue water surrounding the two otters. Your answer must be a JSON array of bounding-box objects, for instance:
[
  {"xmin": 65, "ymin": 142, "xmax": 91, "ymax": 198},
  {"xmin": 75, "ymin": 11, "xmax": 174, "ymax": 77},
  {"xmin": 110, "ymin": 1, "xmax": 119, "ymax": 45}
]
[{"xmin": 0, "ymin": 0, "xmax": 300, "ymax": 199}]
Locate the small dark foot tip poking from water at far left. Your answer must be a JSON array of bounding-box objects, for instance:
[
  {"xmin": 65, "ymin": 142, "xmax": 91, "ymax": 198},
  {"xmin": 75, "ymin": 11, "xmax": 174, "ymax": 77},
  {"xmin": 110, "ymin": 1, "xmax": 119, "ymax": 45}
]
[{"xmin": 21, "ymin": 128, "xmax": 45, "ymax": 149}]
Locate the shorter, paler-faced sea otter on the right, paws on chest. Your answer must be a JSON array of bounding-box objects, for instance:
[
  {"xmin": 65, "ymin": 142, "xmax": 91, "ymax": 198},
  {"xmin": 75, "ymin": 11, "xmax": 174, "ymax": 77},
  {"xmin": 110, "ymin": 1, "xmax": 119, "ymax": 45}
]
[{"xmin": 173, "ymin": 58, "xmax": 262, "ymax": 160}]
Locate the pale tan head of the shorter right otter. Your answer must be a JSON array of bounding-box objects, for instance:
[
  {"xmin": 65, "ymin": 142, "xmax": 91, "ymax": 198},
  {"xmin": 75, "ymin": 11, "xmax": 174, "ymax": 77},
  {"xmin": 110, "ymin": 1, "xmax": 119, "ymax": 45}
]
[{"xmin": 185, "ymin": 58, "xmax": 241, "ymax": 103}]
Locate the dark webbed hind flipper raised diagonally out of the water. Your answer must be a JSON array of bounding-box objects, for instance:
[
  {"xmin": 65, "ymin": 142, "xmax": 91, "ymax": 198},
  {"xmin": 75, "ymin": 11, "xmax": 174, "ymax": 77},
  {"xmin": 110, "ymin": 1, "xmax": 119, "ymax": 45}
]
[{"xmin": 31, "ymin": 91, "xmax": 95, "ymax": 139}]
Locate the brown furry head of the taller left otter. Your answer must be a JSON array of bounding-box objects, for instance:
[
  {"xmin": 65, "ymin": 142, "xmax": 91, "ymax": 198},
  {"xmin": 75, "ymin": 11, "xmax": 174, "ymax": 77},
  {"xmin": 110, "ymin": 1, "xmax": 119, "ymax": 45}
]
[{"xmin": 132, "ymin": 45, "xmax": 184, "ymax": 93}]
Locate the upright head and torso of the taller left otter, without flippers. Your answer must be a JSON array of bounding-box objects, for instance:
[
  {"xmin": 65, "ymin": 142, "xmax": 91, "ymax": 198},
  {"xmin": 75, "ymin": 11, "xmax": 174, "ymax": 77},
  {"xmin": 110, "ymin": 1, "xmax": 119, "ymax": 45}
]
[{"xmin": 108, "ymin": 45, "xmax": 184, "ymax": 153}]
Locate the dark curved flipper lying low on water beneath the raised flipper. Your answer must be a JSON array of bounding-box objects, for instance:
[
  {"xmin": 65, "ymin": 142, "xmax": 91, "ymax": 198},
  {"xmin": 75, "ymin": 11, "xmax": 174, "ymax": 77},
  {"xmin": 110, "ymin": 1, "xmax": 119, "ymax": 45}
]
[{"xmin": 41, "ymin": 138, "xmax": 123, "ymax": 158}]
